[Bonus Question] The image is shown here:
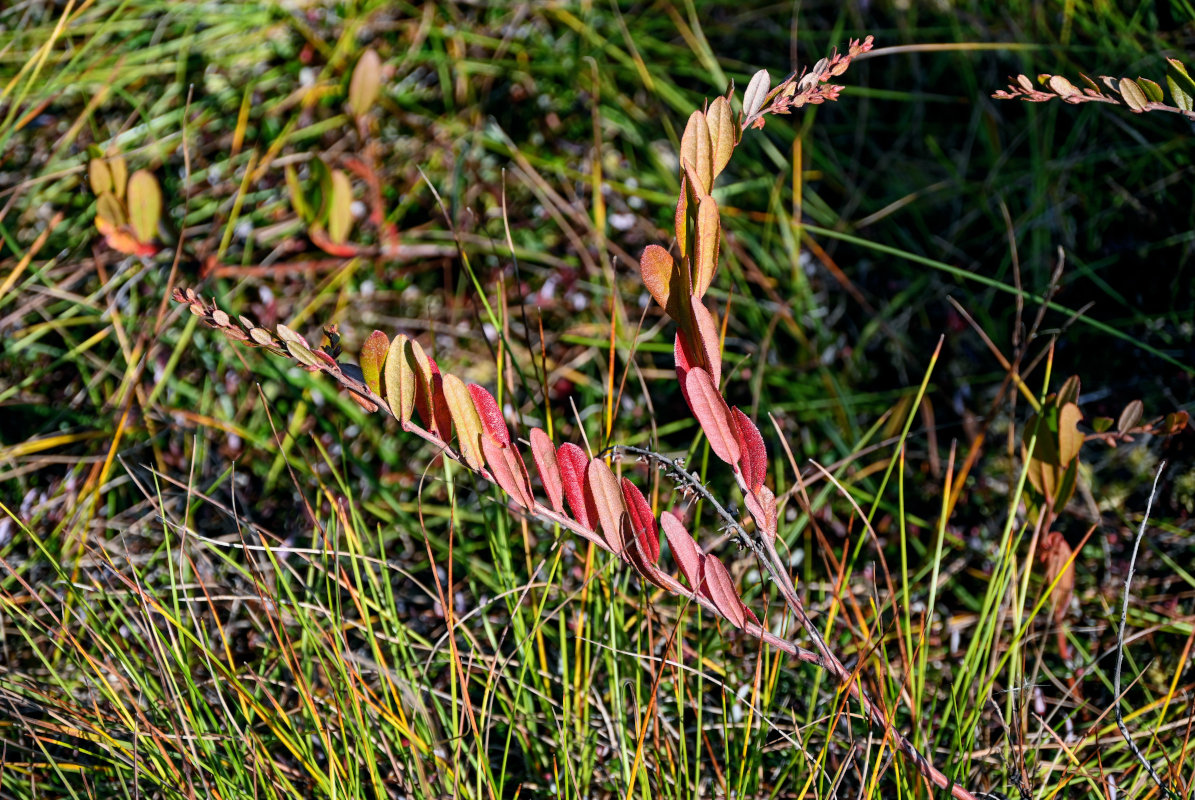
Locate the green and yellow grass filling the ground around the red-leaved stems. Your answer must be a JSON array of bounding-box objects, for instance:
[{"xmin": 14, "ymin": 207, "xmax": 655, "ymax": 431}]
[{"xmin": 0, "ymin": 0, "xmax": 1195, "ymax": 800}]
